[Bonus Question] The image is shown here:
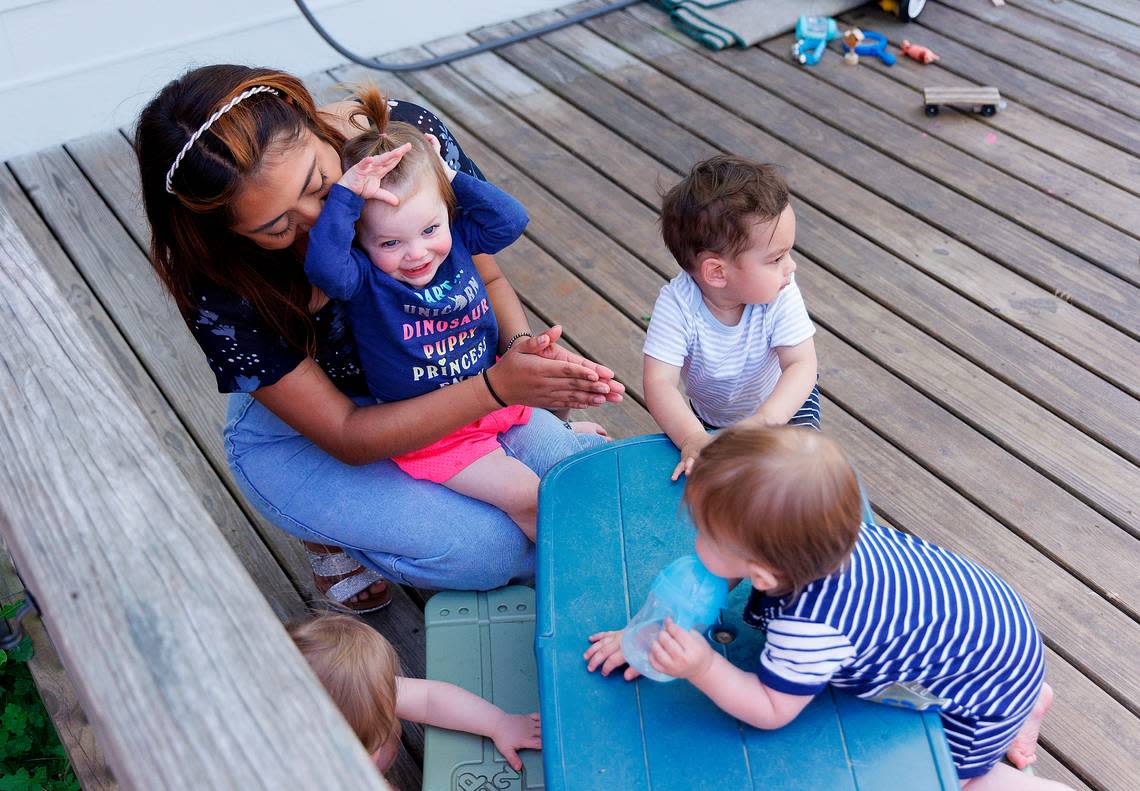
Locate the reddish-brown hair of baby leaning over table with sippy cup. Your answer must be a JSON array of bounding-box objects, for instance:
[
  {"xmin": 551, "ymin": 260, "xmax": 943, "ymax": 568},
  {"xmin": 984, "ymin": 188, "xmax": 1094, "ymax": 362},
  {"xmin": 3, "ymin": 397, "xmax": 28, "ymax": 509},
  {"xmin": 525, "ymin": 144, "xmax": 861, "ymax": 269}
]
[{"xmin": 685, "ymin": 426, "xmax": 863, "ymax": 594}]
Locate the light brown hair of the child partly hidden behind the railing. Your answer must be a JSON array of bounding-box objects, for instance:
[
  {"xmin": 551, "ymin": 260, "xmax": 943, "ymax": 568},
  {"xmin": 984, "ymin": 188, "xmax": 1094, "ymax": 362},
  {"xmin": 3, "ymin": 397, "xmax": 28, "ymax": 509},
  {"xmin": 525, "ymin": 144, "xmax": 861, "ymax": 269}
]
[{"xmin": 286, "ymin": 613, "xmax": 400, "ymax": 755}]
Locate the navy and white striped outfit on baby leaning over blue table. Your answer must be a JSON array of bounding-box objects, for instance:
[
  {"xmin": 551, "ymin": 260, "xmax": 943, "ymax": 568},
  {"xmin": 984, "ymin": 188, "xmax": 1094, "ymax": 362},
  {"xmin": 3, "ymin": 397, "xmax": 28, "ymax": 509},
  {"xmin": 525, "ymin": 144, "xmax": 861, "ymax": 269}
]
[{"xmin": 744, "ymin": 522, "xmax": 1044, "ymax": 780}]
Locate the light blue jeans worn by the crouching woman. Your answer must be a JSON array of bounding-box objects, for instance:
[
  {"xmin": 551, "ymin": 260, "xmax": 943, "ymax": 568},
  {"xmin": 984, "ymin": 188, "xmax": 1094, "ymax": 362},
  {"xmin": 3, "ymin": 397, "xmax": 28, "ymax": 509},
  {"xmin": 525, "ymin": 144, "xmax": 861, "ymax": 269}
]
[{"xmin": 225, "ymin": 393, "xmax": 604, "ymax": 590}]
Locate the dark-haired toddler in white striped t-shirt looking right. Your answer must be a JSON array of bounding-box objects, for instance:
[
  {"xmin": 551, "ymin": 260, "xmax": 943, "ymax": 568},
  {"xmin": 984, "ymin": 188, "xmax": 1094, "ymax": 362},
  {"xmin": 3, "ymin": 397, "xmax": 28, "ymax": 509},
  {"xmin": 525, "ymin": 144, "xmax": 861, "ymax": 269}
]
[{"xmin": 644, "ymin": 156, "xmax": 820, "ymax": 480}]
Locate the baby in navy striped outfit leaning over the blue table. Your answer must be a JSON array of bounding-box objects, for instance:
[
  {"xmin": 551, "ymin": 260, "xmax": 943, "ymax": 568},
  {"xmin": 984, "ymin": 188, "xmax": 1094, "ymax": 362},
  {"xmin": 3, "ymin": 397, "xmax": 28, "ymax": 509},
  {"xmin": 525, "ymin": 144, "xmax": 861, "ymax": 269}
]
[{"xmin": 586, "ymin": 427, "xmax": 1066, "ymax": 791}]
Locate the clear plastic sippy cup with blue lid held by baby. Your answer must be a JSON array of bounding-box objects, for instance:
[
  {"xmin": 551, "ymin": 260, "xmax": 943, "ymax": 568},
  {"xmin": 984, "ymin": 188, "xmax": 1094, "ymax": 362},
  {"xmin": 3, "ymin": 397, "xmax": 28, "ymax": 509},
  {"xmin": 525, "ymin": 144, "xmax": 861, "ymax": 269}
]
[{"xmin": 621, "ymin": 555, "xmax": 728, "ymax": 682}]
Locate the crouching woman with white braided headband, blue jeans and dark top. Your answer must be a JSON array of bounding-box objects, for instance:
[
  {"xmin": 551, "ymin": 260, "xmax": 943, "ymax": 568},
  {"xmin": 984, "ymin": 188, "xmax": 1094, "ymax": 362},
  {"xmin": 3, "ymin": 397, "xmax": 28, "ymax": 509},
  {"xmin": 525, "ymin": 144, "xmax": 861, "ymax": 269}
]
[{"xmin": 136, "ymin": 66, "xmax": 624, "ymax": 611}]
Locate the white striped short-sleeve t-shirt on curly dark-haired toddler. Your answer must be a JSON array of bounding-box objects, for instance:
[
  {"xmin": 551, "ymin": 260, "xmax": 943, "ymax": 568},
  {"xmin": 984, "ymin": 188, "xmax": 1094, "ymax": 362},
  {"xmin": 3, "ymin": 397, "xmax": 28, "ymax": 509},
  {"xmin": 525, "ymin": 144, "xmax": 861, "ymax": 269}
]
[{"xmin": 644, "ymin": 272, "xmax": 815, "ymax": 426}]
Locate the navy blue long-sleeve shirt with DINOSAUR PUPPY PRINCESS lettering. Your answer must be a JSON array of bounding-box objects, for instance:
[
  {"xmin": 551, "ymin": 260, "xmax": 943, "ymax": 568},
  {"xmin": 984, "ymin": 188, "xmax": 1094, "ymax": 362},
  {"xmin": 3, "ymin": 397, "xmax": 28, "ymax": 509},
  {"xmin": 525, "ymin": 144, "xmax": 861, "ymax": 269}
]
[{"xmin": 304, "ymin": 173, "xmax": 528, "ymax": 401}]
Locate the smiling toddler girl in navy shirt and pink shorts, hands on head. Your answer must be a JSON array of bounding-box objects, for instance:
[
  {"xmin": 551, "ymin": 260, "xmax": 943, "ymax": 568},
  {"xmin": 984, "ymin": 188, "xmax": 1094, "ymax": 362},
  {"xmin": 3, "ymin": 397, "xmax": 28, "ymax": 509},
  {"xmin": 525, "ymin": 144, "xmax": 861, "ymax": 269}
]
[{"xmin": 304, "ymin": 89, "xmax": 603, "ymax": 540}]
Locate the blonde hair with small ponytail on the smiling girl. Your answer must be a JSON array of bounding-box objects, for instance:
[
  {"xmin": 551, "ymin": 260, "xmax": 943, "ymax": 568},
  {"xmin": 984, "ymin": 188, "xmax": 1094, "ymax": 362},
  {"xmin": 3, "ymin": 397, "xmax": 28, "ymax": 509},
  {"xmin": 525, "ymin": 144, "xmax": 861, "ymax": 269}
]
[{"xmin": 341, "ymin": 84, "xmax": 456, "ymax": 220}]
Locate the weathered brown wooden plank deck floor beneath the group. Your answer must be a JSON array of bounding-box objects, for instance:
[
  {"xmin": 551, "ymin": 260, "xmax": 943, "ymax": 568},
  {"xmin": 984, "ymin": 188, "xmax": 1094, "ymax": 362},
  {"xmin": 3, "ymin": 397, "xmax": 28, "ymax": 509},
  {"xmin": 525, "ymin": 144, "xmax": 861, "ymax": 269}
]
[{"xmin": 0, "ymin": 0, "xmax": 1140, "ymax": 791}]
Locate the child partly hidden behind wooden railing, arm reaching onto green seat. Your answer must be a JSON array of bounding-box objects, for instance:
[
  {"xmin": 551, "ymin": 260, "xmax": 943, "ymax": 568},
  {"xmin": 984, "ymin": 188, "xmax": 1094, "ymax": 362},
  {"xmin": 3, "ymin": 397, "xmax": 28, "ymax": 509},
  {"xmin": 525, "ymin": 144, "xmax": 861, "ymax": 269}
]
[{"xmin": 288, "ymin": 613, "xmax": 543, "ymax": 772}]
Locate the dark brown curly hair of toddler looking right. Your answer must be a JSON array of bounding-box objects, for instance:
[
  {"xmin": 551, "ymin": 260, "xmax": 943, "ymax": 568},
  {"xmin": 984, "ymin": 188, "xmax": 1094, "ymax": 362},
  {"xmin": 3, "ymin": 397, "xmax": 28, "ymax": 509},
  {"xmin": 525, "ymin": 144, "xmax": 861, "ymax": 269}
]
[{"xmin": 661, "ymin": 154, "xmax": 788, "ymax": 272}]
